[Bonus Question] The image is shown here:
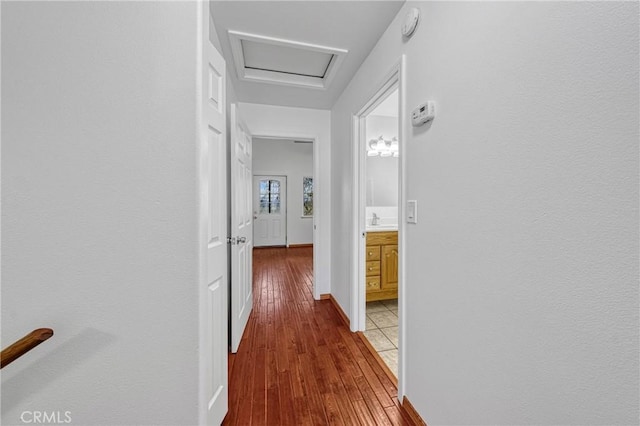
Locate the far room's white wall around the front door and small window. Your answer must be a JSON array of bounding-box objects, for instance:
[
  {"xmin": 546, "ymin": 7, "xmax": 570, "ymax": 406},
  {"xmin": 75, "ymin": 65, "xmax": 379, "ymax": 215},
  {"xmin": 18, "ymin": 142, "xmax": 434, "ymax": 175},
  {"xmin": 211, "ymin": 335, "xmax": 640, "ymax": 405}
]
[{"xmin": 253, "ymin": 138, "xmax": 313, "ymax": 245}]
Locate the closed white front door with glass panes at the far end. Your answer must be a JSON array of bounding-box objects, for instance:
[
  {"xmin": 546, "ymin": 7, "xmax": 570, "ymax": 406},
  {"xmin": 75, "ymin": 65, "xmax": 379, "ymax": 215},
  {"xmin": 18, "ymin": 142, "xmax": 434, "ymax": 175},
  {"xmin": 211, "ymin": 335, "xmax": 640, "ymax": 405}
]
[{"xmin": 253, "ymin": 176, "xmax": 288, "ymax": 247}]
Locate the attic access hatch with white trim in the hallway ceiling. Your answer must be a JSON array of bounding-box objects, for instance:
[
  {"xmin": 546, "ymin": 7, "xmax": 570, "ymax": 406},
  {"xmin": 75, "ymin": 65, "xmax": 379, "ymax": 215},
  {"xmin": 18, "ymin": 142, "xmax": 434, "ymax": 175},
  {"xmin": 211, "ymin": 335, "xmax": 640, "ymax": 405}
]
[{"xmin": 228, "ymin": 30, "xmax": 349, "ymax": 90}]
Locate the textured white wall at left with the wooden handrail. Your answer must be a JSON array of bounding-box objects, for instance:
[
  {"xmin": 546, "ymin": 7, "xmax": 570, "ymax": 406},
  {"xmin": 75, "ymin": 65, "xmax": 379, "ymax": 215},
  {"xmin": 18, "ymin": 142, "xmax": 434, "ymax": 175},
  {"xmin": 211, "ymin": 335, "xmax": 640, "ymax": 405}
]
[{"xmin": 1, "ymin": 2, "xmax": 198, "ymax": 425}]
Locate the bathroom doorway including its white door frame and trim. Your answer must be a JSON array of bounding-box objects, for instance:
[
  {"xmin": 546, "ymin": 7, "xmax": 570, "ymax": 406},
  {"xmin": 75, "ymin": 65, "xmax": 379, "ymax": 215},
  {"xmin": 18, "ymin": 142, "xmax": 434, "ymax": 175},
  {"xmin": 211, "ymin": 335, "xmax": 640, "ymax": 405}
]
[{"xmin": 352, "ymin": 58, "xmax": 405, "ymax": 398}]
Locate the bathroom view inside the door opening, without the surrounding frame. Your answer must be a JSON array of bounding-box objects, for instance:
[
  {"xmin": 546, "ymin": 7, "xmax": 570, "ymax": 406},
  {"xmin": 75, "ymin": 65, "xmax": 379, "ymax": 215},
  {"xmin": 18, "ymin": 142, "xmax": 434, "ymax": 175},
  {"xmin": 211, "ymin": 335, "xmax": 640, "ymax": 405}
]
[{"xmin": 363, "ymin": 88, "xmax": 400, "ymax": 377}]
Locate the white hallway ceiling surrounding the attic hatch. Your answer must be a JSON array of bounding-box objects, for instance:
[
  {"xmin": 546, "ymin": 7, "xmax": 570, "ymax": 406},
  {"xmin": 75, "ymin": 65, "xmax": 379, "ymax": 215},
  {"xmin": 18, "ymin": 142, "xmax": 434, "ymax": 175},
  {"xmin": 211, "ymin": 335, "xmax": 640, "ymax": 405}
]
[{"xmin": 211, "ymin": 0, "xmax": 404, "ymax": 109}]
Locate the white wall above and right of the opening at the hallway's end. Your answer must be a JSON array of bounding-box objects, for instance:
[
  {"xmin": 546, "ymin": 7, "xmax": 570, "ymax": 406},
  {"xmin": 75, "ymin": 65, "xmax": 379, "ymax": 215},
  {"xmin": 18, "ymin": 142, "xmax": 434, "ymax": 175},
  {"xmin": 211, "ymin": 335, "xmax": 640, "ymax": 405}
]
[{"xmin": 240, "ymin": 103, "xmax": 332, "ymax": 297}]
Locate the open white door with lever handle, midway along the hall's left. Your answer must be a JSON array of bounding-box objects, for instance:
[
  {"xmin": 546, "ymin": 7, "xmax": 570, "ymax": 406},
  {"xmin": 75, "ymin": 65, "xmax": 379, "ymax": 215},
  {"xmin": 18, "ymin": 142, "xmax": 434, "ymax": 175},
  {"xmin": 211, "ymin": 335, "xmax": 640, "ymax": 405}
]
[{"xmin": 230, "ymin": 104, "xmax": 253, "ymax": 353}]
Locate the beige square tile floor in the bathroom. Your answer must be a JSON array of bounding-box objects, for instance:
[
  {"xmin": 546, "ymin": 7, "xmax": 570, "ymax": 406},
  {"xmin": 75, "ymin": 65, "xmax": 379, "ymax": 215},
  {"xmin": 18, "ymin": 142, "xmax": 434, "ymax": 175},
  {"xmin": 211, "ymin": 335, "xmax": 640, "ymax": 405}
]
[{"xmin": 364, "ymin": 299, "xmax": 398, "ymax": 376}]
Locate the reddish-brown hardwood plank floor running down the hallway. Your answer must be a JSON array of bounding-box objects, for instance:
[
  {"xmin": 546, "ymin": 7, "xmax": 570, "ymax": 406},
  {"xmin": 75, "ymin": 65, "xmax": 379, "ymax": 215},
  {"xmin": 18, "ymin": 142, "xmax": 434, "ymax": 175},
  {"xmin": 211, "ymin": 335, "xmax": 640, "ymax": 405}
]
[{"xmin": 223, "ymin": 248, "xmax": 414, "ymax": 426}]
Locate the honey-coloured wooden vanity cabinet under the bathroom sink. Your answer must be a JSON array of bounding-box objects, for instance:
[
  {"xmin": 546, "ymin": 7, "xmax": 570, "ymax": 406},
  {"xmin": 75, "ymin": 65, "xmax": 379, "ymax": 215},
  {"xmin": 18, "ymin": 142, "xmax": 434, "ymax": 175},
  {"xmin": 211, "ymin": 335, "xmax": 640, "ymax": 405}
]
[{"xmin": 365, "ymin": 231, "xmax": 398, "ymax": 302}]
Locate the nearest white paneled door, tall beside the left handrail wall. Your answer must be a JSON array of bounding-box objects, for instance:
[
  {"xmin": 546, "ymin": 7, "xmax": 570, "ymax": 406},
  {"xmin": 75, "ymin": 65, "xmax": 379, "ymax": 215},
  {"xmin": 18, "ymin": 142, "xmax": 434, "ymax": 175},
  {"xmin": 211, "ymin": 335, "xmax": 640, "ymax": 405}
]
[{"xmin": 198, "ymin": 1, "xmax": 229, "ymax": 425}]
